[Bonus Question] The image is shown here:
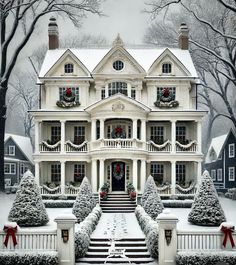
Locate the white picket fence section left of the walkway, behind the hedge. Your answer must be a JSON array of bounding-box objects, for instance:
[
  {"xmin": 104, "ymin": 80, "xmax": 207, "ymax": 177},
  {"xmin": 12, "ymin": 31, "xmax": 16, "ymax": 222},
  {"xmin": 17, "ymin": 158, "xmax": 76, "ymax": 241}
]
[{"xmin": 0, "ymin": 229, "xmax": 57, "ymax": 251}]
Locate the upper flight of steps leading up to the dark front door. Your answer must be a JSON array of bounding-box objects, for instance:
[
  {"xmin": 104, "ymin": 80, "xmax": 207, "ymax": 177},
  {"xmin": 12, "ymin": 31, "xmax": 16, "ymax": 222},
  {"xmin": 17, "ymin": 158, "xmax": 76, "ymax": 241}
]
[{"xmin": 100, "ymin": 192, "xmax": 137, "ymax": 213}]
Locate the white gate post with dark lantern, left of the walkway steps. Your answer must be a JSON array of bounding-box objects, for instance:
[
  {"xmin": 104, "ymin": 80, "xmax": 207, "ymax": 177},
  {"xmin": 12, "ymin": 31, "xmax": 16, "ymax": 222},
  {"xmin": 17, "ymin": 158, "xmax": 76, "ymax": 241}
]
[{"xmin": 55, "ymin": 214, "xmax": 77, "ymax": 265}]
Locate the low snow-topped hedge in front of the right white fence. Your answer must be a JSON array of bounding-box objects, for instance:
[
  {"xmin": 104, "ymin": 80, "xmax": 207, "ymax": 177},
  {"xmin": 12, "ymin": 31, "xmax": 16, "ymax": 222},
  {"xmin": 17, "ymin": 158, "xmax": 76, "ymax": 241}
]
[{"xmin": 176, "ymin": 251, "xmax": 236, "ymax": 265}]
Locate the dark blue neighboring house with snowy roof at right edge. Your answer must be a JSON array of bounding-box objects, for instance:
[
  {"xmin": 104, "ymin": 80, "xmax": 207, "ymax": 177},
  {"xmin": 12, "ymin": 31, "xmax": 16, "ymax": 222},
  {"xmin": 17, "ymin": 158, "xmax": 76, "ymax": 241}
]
[{"xmin": 205, "ymin": 130, "xmax": 236, "ymax": 191}]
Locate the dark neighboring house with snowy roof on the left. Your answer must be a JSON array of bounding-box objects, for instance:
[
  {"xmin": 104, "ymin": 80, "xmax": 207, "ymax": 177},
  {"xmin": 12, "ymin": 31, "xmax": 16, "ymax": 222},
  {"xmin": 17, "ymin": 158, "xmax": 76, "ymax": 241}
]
[{"xmin": 4, "ymin": 133, "xmax": 34, "ymax": 186}]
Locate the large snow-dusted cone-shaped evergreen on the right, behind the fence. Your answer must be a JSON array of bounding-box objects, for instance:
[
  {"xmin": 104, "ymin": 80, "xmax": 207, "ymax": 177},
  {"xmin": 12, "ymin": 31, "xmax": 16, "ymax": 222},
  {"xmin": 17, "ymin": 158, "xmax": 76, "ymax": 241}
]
[{"xmin": 188, "ymin": 171, "xmax": 226, "ymax": 226}]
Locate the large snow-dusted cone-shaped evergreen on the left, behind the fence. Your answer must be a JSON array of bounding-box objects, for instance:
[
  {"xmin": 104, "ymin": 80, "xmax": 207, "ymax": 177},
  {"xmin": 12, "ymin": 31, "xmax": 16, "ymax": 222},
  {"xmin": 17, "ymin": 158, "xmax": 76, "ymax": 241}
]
[{"xmin": 8, "ymin": 170, "xmax": 49, "ymax": 226}]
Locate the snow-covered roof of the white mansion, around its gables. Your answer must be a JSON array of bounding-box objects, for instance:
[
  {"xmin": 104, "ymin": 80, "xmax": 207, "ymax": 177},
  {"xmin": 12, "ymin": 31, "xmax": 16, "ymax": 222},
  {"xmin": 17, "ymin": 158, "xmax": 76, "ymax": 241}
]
[{"xmin": 39, "ymin": 47, "xmax": 197, "ymax": 77}]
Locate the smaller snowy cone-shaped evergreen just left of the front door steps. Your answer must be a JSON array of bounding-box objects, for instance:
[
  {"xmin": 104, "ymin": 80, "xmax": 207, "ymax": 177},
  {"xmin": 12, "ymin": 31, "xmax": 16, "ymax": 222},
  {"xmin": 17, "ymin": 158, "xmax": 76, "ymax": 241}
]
[{"xmin": 72, "ymin": 177, "xmax": 96, "ymax": 223}]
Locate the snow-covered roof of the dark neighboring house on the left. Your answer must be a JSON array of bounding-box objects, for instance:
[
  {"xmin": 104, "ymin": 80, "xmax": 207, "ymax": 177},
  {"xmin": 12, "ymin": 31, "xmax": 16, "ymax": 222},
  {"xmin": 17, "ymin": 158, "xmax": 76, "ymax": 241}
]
[{"xmin": 4, "ymin": 133, "xmax": 34, "ymax": 164}]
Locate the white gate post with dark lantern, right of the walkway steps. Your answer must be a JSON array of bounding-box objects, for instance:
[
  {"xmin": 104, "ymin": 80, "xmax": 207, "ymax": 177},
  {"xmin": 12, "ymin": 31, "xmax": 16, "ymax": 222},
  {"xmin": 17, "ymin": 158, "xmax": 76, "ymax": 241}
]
[{"xmin": 157, "ymin": 210, "xmax": 179, "ymax": 265}]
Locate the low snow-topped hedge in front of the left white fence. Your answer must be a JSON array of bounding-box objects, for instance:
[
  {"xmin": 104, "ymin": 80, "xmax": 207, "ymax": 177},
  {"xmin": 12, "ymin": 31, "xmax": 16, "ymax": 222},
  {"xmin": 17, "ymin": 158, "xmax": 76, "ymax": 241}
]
[{"xmin": 0, "ymin": 251, "xmax": 59, "ymax": 265}]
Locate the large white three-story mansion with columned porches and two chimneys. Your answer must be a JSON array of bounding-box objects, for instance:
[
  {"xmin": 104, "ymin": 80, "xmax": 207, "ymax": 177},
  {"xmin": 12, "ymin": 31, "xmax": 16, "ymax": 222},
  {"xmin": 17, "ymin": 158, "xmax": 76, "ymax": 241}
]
[{"xmin": 32, "ymin": 18, "xmax": 205, "ymax": 195}]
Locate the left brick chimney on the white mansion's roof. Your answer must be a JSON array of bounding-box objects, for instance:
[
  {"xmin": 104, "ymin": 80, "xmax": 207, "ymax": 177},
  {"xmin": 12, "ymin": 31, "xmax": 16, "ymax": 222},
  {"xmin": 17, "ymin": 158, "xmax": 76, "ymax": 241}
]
[{"xmin": 48, "ymin": 17, "xmax": 59, "ymax": 50}]
